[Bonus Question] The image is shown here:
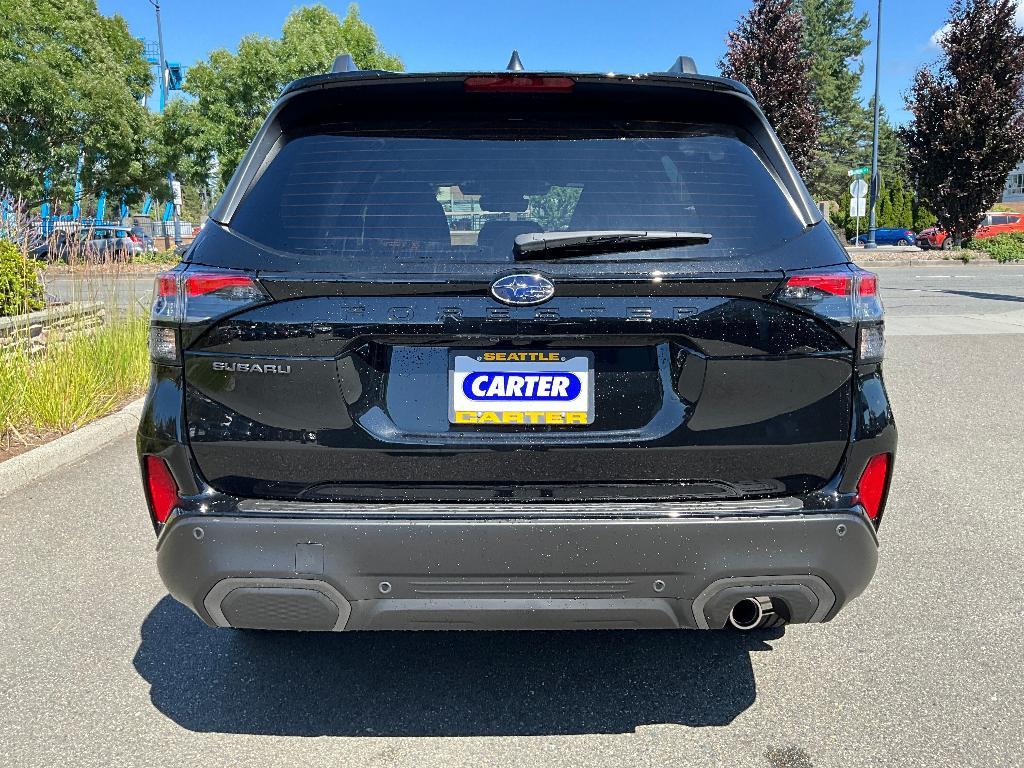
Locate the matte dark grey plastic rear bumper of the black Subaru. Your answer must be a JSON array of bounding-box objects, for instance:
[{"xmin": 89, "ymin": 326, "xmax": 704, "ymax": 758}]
[{"xmin": 158, "ymin": 503, "xmax": 878, "ymax": 630}]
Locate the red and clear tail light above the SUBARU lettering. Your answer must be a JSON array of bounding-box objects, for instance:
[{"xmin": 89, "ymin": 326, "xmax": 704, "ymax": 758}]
[{"xmin": 150, "ymin": 269, "xmax": 267, "ymax": 365}]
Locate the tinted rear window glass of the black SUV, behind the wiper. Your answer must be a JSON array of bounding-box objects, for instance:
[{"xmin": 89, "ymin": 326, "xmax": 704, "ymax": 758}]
[{"xmin": 229, "ymin": 126, "xmax": 803, "ymax": 271}]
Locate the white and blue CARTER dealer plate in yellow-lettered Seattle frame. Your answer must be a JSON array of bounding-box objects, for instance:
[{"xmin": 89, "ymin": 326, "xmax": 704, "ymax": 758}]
[{"xmin": 449, "ymin": 349, "xmax": 594, "ymax": 427}]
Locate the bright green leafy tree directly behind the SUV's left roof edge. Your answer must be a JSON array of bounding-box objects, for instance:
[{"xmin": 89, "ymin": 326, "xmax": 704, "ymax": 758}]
[{"xmin": 169, "ymin": 0, "xmax": 402, "ymax": 184}]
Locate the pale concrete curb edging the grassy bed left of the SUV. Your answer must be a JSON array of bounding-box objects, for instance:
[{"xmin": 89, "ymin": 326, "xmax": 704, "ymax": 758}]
[{"xmin": 0, "ymin": 397, "xmax": 144, "ymax": 499}]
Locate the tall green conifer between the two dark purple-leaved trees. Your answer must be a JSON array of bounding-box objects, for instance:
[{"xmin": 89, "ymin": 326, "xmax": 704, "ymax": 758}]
[{"xmin": 800, "ymin": 0, "xmax": 869, "ymax": 199}]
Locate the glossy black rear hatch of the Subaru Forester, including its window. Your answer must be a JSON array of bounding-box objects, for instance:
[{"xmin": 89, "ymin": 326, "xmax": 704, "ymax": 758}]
[{"xmin": 176, "ymin": 72, "xmax": 855, "ymax": 501}]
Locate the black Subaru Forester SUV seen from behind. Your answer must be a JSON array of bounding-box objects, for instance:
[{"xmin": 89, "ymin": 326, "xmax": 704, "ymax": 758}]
[{"xmin": 138, "ymin": 57, "xmax": 896, "ymax": 630}]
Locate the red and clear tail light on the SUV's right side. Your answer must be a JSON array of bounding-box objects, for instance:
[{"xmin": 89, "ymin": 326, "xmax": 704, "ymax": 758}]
[{"xmin": 775, "ymin": 266, "xmax": 886, "ymax": 362}]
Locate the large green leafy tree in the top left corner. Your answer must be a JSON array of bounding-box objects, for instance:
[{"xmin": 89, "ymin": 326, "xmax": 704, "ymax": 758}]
[{"xmin": 0, "ymin": 0, "xmax": 155, "ymax": 204}]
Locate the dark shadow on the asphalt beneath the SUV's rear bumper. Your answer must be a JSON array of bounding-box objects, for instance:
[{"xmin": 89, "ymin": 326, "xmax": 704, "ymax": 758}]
[{"xmin": 134, "ymin": 597, "xmax": 782, "ymax": 736}]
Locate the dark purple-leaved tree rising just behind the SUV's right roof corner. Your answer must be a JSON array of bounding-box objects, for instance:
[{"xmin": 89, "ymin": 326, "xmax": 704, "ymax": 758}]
[{"xmin": 719, "ymin": 0, "xmax": 818, "ymax": 176}]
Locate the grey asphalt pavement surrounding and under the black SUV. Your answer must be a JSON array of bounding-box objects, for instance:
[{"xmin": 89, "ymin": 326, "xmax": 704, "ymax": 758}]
[{"xmin": 0, "ymin": 266, "xmax": 1024, "ymax": 768}]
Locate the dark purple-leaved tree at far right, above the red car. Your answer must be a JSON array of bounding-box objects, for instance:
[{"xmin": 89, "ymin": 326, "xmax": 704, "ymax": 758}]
[{"xmin": 905, "ymin": 0, "xmax": 1024, "ymax": 243}]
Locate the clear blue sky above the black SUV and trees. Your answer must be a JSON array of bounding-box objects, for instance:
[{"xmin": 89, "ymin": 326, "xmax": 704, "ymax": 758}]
[{"xmin": 98, "ymin": 0, "xmax": 1024, "ymax": 123}]
